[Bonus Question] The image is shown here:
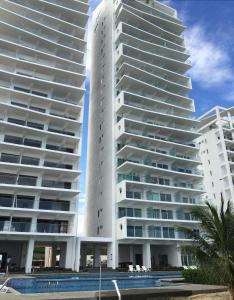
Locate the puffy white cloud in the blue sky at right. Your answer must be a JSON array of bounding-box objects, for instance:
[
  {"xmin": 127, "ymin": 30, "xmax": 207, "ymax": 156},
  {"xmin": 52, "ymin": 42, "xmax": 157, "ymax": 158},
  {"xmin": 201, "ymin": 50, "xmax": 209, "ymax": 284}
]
[{"xmin": 185, "ymin": 24, "xmax": 234, "ymax": 87}]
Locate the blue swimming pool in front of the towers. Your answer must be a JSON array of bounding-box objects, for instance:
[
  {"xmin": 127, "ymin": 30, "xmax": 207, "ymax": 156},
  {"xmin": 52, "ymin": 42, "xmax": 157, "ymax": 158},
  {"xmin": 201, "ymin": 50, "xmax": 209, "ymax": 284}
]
[{"xmin": 9, "ymin": 272, "xmax": 181, "ymax": 294}]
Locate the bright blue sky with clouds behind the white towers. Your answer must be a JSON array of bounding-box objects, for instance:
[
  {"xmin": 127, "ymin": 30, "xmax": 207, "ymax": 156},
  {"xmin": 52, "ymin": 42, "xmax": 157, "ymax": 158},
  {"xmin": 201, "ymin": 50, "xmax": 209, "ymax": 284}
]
[{"xmin": 79, "ymin": 0, "xmax": 234, "ymax": 233}]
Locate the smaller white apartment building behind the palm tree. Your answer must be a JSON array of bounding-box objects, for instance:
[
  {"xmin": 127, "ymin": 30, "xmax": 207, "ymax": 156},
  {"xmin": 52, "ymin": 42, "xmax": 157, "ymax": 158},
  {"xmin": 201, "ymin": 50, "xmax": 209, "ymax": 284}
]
[{"xmin": 198, "ymin": 106, "xmax": 234, "ymax": 205}]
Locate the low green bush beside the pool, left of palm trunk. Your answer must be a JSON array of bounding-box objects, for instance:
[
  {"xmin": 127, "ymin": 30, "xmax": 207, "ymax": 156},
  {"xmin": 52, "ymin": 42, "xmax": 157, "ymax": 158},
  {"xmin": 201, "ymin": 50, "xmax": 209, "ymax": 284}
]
[{"xmin": 182, "ymin": 268, "xmax": 225, "ymax": 285}]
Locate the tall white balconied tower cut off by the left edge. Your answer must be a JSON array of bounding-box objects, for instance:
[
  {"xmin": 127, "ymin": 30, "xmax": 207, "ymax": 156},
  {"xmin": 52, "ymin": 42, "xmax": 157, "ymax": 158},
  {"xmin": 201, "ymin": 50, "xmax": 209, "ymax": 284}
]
[{"xmin": 0, "ymin": 0, "xmax": 88, "ymax": 272}]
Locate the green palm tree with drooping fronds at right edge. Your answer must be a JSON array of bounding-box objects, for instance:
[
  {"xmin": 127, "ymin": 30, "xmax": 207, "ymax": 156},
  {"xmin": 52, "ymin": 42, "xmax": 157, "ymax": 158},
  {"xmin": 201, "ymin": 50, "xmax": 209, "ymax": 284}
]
[{"xmin": 178, "ymin": 195, "xmax": 234, "ymax": 299}]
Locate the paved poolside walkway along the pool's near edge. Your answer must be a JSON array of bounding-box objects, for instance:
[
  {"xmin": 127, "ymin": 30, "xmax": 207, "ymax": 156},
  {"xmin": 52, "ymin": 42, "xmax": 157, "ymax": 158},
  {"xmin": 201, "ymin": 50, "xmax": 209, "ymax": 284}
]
[{"xmin": 0, "ymin": 284, "xmax": 227, "ymax": 300}]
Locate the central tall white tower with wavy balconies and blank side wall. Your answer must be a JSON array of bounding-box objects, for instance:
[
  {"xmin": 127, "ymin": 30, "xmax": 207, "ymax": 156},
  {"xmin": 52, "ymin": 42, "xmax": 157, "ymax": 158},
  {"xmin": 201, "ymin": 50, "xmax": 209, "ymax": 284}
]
[{"xmin": 86, "ymin": 0, "xmax": 203, "ymax": 268}]
